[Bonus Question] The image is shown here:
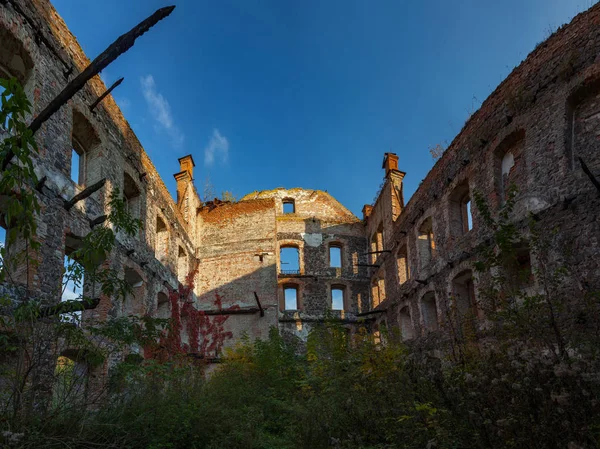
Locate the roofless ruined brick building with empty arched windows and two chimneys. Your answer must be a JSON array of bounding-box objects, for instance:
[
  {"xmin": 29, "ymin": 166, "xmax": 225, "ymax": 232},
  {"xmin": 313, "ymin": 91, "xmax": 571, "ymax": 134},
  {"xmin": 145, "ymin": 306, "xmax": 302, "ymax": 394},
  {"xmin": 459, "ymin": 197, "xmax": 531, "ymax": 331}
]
[{"xmin": 0, "ymin": 0, "xmax": 600, "ymax": 386}]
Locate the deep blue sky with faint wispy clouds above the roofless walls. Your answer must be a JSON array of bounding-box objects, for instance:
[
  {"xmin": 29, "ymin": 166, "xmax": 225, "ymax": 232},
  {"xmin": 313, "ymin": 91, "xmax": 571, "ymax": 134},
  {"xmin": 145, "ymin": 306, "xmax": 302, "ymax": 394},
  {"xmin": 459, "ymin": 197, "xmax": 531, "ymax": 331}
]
[{"xmin": 53, "ymin": 0, "xmax": 594, "ymax": 216}]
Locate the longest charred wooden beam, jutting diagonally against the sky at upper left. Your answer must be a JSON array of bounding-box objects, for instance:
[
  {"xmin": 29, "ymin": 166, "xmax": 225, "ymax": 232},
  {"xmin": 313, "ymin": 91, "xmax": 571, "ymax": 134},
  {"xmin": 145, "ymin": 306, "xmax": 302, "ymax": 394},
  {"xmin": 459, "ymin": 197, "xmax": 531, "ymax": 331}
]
[{"xmin": 1, "ymin": 2, "xmax": 175, "ymax": 171}]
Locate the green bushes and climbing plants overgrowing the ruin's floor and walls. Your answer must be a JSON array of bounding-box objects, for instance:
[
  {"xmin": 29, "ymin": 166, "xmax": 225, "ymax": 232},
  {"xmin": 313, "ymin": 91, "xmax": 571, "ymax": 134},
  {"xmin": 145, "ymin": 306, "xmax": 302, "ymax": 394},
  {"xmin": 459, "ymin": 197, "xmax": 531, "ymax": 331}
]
[{"xmin": 0, "ymin": 81, "xmax": 600, "ymax": 449}]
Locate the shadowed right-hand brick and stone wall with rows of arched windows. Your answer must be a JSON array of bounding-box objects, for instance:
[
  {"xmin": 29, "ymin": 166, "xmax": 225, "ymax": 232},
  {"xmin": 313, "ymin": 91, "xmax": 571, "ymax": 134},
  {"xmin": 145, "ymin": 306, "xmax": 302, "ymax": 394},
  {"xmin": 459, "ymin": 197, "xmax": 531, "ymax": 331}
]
[{"xmin": 365, "ymin": 5, "xmax": 600, "ymax": 337}]
